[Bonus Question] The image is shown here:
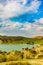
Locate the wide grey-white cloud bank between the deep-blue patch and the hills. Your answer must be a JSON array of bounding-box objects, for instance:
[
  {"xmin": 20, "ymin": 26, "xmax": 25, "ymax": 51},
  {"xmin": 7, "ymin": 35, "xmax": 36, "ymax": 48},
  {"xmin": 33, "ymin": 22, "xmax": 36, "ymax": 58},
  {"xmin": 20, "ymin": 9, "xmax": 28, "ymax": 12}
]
[{"xmin": 0, "ymin": 18, "xmax": 43, "ymax": 37}]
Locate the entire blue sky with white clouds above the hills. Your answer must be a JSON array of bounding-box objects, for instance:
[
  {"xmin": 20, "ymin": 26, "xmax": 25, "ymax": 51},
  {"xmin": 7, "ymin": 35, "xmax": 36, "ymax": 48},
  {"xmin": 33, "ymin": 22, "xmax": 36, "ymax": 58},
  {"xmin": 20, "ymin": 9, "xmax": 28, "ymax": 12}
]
[{"xmin": 0, "ymin": 0, "xmax": 43, "ymax": 37}]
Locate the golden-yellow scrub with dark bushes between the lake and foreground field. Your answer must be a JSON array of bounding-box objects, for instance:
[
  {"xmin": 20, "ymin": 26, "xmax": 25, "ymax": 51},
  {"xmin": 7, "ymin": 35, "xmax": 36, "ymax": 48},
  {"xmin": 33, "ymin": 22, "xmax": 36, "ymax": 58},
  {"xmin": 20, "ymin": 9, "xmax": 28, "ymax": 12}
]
[{"xmin": 0, "ymin": 45, "xmax": 43, "ymax": 62}]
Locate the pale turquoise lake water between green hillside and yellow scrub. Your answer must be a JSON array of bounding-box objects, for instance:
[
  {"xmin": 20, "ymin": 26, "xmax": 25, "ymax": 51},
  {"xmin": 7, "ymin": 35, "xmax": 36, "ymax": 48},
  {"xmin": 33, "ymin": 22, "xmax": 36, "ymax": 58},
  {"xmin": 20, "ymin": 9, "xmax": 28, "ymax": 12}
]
[{"xmin": 0, "ymin": 44, "xmax": 37, "ymax": 52}]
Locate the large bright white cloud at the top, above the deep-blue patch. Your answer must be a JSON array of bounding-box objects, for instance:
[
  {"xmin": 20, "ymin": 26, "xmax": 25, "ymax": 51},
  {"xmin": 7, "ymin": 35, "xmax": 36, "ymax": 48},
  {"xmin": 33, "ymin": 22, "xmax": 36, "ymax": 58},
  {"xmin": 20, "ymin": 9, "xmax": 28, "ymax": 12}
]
[{"xmin": 0, "ymin": 0, "xmax": 41, "ymax": 18}]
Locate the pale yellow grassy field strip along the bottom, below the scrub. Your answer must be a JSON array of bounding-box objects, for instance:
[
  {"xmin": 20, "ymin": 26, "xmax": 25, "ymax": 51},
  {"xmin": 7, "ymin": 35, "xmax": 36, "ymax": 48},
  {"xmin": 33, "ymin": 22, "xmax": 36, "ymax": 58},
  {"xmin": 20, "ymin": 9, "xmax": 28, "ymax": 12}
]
[{"xmin": 0, "ymin": 59, "xmax": 43, "ymax": 65}]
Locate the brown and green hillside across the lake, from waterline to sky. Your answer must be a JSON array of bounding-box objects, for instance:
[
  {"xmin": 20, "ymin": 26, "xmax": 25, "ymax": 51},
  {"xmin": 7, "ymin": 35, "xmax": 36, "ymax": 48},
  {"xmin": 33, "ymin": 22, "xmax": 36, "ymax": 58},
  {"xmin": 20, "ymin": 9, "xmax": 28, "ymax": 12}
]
[{"xmin": 0, "ymin": 36, "xmax": 43, "ymax": 44}]
